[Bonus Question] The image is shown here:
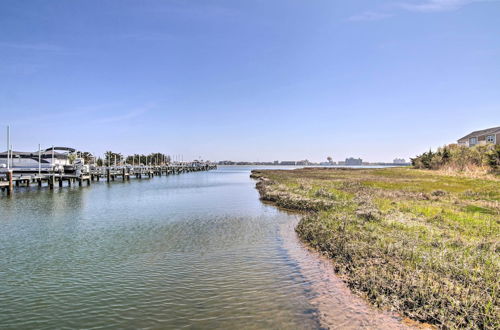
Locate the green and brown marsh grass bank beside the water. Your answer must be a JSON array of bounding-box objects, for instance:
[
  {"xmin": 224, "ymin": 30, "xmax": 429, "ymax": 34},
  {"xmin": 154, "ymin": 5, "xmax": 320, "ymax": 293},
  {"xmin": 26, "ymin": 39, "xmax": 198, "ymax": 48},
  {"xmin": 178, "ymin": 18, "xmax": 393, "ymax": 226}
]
[{"xmin": 252, "ymin": 168, "xmax": 500, "ymax": 328}]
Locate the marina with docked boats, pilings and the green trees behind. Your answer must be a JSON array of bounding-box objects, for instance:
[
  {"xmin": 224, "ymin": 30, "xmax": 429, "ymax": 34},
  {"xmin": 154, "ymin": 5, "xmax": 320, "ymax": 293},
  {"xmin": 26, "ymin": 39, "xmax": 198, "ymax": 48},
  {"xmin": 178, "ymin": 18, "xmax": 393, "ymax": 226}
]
[{"xmin": 0, "ymin": 126, "xmax": 217, "ymax": 196}]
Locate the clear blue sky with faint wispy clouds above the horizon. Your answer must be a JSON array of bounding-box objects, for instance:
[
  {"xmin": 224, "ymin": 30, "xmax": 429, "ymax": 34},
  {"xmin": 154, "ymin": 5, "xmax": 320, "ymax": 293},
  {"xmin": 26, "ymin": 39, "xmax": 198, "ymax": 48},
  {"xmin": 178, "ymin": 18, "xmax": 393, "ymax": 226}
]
[{"xmin": 0, "ymin": 0, "xmax": 500, "ymax": 161}]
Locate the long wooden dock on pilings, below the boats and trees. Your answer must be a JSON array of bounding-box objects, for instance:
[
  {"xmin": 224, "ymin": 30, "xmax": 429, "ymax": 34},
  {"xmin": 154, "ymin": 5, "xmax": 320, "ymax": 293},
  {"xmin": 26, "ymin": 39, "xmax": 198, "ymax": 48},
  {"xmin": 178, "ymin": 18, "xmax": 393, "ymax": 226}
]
[{"xmin": 0, "ymin": 163, "xmax": 217, "ymax": 196}]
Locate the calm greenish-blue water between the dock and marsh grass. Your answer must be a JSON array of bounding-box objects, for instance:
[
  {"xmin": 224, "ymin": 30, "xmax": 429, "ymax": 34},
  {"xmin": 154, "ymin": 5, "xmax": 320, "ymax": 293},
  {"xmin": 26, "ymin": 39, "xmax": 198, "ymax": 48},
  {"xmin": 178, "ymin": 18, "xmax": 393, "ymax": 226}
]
[{"xmin": 0, "ymin": 167, "xmax": 408, "ymax": 329}]
